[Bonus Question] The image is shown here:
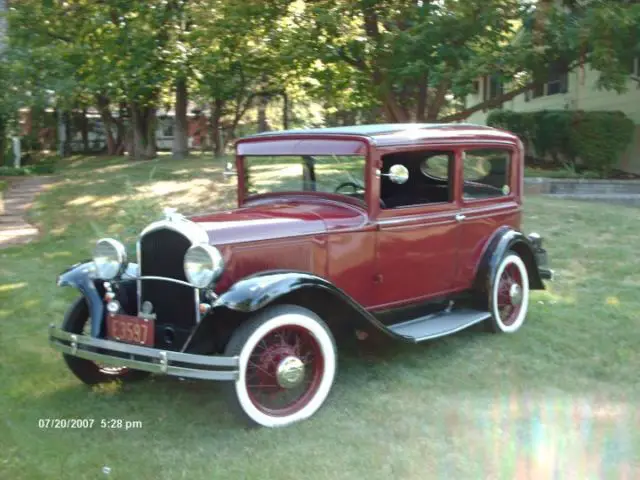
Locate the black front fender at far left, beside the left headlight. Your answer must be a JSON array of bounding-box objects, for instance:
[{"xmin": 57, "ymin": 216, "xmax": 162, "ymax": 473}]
[{"xmin": 57, "ymin": 260, "xmax": 138, "ymax": 338}]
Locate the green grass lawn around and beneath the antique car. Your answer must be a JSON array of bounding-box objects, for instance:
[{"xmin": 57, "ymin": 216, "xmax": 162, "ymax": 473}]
[{"xmin": 0, "ymin": 158, "xmax": 640, "ymax": 480}]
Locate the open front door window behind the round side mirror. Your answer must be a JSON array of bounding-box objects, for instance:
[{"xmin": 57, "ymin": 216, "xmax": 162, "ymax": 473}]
[{"xmin": 380, "ymin": 150, "xmax": 455, "ymax": 209}]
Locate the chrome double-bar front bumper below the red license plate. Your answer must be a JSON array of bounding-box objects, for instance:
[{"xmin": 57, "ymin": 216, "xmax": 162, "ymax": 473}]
[{"xmin": 49, "ymin": 325, "xmax": 239, "ymax": 380}]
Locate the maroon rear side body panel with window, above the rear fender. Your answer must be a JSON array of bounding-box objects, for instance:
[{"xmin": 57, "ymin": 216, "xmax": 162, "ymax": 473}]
[{"xmin": 457, "ymin": 145, "xmax": 522, "ymax": 288}]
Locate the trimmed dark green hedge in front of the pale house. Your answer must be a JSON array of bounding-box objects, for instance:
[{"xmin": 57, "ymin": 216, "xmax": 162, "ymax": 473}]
[{"xmin": 487, "ymin": 110, "xmax": 634, "ymax": 175}]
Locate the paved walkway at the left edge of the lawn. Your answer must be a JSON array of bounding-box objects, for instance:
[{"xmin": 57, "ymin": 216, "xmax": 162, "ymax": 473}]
[{"xmin": 0, "ymin": 176, "xmax": 52, "ymax": 249}]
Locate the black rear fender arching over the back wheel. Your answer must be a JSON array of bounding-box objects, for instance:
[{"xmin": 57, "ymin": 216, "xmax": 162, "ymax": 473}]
[{"xmin": 474, "ymin": 227, "xmax": 545, "ymax": 294}]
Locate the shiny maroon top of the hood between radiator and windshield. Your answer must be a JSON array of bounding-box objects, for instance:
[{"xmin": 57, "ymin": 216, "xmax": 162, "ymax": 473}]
[{"xmin": 191, "ymin": 203, "xmax": 327, "ymax": 245}]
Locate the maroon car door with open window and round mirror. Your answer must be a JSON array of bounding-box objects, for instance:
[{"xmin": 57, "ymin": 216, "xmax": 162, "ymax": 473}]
[{"xmin": 374, "ymin": 150, "xmax": 458, "ymax": 309}]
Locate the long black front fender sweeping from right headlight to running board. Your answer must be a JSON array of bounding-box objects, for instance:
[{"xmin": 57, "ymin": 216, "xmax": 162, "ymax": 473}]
[{"xmin": 213, "ymin": 270, "xmax": 406, "ymax": 340}]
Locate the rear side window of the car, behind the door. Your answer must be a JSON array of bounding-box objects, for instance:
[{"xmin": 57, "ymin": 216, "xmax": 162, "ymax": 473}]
[{"xmin": 462, "ymin": 149, "xmax": 511, "ymax": 200}]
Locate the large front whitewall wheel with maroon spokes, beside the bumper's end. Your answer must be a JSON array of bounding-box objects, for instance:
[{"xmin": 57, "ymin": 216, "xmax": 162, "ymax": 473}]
[{"xmin": 225, "ymin": 305, "xmax": 337, "ymax": 427}]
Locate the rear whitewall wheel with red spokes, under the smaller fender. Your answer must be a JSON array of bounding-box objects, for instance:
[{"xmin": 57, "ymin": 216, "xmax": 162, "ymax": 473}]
[{"xmin": 489, "ymin": 252, "xmax": 529, "ymax": 333}]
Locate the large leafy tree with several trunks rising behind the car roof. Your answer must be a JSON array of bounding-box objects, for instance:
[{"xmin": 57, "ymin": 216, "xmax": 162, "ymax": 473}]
[{"xmin": 292, "ymin": 0, "xmax": 638, "ymax": 122}]
